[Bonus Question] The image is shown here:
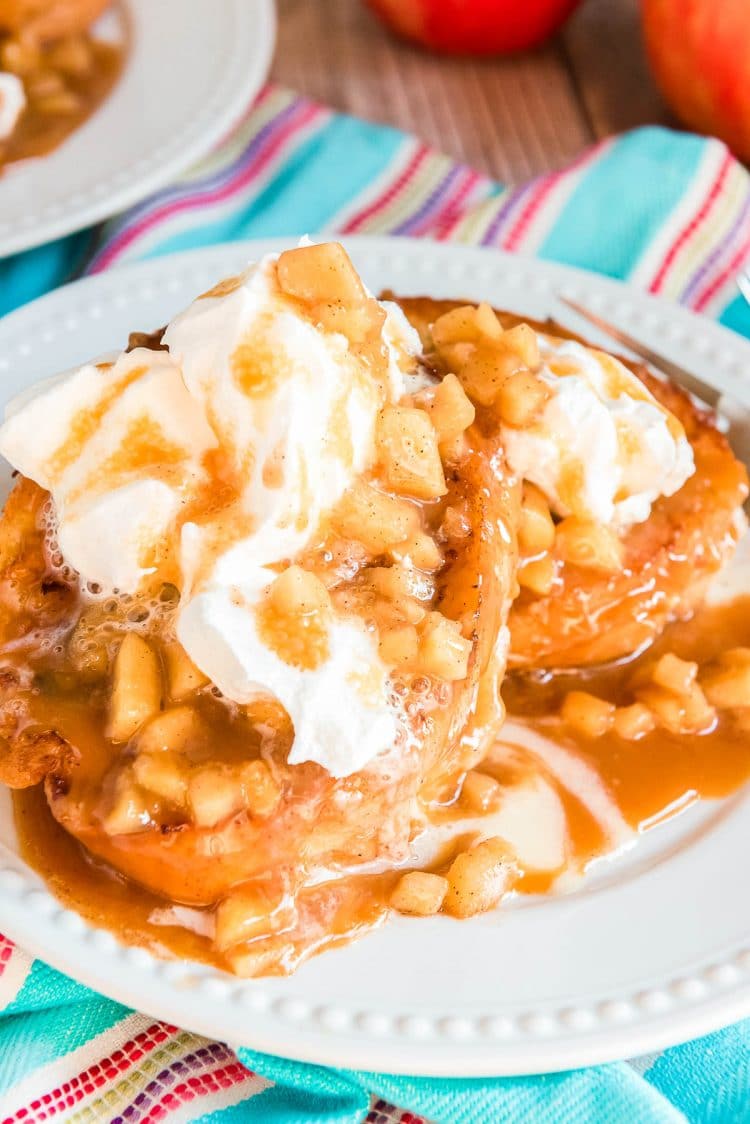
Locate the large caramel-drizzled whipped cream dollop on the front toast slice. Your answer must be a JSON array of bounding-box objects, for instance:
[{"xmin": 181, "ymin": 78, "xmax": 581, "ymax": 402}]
[{"xmin": 0, "ymin": 250, "xmax": 419, "ymax": 777}]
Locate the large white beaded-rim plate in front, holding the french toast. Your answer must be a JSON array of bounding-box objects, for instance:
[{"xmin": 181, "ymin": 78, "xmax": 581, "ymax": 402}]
[{"xmin": 0, "ymin": 238, "xmax": 750, "ymax": 1076}]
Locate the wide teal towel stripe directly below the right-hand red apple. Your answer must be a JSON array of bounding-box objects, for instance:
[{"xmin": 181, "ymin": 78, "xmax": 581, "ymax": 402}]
[{"xmin": 539, "ymin": 128, "xmax": 707, "ymax": 278}]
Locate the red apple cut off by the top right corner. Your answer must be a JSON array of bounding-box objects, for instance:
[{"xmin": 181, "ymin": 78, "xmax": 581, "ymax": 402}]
[{"xmin": 642, "ymin": 0, "xmax": 750, "ymax": 160}]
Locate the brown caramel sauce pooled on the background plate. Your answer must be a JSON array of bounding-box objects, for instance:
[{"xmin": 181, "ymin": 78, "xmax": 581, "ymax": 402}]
[{"xmin": 0, "ymin": 36, "xmax": 126, "ymax": 175}]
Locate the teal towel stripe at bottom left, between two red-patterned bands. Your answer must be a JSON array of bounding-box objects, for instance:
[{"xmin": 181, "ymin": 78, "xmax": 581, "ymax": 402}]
[{"xmin": 0, "ymin": 992, "xmax": 130, "ymax": 1092}]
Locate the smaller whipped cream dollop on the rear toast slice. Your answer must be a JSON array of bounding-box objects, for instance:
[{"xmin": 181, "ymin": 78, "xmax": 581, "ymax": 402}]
[{"xmin": 503, "ymin": 334, "xmax": 695, "ymax": 531}]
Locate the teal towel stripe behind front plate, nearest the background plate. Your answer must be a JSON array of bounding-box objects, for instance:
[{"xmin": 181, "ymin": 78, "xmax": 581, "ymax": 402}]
[{"xmin": 132, "ymin": 117, "xmax": 404, "ymax": 257}]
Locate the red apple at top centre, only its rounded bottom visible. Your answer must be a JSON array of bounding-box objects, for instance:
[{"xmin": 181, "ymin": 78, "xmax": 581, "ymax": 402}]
[{"xmin": 368, "ymin": 0, "xmax": 580, "ymax": 55}]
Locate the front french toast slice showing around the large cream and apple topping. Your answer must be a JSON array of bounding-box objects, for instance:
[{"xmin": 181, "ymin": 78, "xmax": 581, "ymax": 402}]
[{"xmin": 0, "ymin": 426, "xmax": 519, "ymax": 905}]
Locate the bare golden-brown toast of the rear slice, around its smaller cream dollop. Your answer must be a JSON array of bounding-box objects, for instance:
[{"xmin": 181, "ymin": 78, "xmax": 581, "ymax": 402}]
[{"xmin": 396, "ymin": 297, "xmax": 747, "ymax": 668}]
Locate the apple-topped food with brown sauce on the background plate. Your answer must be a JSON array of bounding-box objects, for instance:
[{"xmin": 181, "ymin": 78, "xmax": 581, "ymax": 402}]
[{"xmin": 0, "ymin": 0, "xmax": 124, "ymax": 172}]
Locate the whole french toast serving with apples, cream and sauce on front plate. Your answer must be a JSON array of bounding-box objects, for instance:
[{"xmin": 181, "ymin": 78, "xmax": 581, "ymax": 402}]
[{"xmin": 0, "ymin": 243, "xmax": 750, "ymax": 976}]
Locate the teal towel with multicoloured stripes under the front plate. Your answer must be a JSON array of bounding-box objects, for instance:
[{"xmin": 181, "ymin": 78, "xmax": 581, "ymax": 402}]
[{"xmin": 0, "ymin": 87, "xmax": 750, "ymax": 1124}]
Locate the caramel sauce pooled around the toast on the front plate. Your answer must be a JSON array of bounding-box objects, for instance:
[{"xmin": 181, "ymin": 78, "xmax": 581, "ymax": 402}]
[{"xmin": 13, "ymin": 597, "xmax": 750, "ymax": 973}]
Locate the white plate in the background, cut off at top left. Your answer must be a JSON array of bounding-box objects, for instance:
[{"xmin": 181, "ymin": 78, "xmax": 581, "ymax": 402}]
[{"xmin": 0, "ymin": 0, "xmax": 275, "ymax": 257}]
